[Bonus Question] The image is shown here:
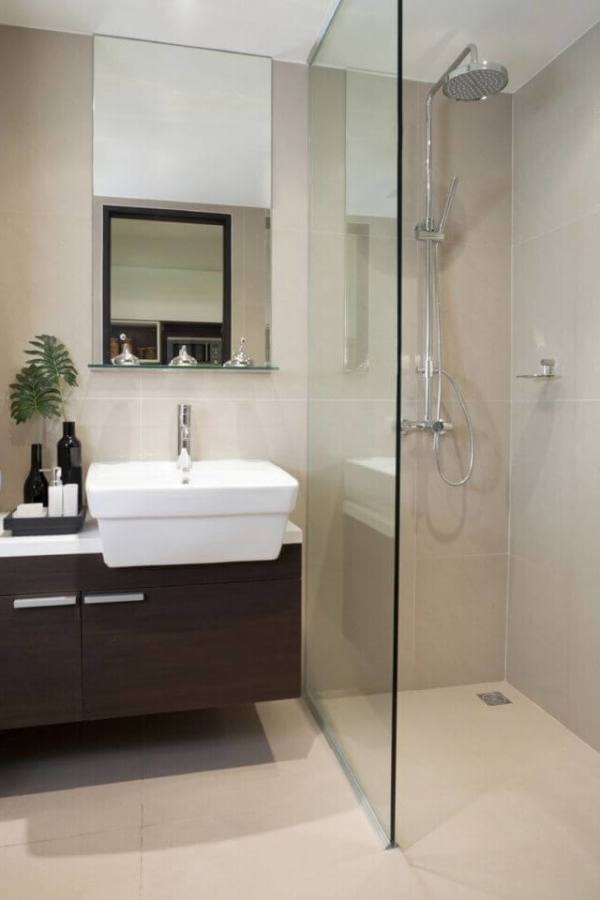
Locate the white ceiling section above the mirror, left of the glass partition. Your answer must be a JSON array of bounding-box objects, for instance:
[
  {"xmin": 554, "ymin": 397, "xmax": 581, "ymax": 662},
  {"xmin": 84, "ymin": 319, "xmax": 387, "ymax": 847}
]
[{"xmin": 0, "ymin": 0, "xmax": 336, "ymax": 62}]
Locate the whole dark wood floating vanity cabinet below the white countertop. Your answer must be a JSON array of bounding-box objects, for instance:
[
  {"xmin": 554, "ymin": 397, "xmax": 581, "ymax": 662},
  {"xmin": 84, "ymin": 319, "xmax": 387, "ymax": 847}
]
[{"xmin": 0, "ymin": 545, "xmax": 301, "ymax": 729}]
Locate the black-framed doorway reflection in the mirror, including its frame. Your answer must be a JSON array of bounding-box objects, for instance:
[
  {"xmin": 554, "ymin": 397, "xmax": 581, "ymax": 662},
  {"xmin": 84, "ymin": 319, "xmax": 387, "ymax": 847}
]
[{"xmin": 102, "ymin": 205, "xmax": 231, "ymax": 366}]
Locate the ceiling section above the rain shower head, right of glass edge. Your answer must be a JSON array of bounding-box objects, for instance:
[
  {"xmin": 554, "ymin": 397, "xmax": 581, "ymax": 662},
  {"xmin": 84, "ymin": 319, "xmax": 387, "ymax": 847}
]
[{"xmin": 403, "ymin": 0, "xmax": 600, "ymax": 91}]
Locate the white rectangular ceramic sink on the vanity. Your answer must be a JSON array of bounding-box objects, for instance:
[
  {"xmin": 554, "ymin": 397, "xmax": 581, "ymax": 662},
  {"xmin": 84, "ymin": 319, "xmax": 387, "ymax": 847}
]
[{"xmin": 86, "ymin": 459, "xmax": 298, "ymax": 567}]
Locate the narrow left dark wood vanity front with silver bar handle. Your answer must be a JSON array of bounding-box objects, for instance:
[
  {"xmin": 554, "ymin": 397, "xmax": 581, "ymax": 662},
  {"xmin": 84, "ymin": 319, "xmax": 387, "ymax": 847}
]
[{"xmin": 0, "ymin": 594, "xmax": 82, "ymax": 729}]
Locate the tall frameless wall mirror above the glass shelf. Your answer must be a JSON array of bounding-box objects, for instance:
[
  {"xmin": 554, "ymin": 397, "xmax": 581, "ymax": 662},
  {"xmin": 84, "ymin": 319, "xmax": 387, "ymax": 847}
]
[{"xmin": 94, "ymin": 38, "xmax": 271, "ymax": 368}]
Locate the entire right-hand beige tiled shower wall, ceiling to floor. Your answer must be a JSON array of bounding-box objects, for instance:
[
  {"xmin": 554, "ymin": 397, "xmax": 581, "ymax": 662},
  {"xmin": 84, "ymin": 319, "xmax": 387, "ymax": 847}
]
[{"xmin": 508, "ymin": 19, "xmax": 600, "ymax": 748}]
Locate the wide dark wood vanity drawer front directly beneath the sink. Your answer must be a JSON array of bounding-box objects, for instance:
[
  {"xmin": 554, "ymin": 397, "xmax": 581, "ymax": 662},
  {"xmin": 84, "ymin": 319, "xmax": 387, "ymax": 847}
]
[{"xmin": 82, "ymin": 579, "xmax": 301, "ymax": 719}]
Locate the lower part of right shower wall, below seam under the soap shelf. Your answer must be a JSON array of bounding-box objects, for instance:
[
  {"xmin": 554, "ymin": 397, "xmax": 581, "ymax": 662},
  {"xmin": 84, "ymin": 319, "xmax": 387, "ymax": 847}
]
[{"xmin": 508, "ymin": 402, "xmax": 600, "ymax": 748}]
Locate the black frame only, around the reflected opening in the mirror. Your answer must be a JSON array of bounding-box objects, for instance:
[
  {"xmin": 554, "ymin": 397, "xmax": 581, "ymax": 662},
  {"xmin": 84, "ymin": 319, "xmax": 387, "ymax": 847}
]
[{"xmin": 102, "ymin": 204, "xmax": 231, "ymax": 364}]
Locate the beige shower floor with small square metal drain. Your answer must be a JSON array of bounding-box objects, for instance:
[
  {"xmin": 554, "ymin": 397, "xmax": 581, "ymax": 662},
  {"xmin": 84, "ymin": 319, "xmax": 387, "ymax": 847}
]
[{"xmin": 326, "ymin": 682, "xmax": 600, "ymax": 900}]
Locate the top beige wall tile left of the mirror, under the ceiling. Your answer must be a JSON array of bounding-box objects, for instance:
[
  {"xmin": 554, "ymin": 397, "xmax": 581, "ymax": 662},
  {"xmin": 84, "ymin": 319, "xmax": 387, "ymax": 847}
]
[{"xmin": 0, "ymin": 25, "xmax": 92, "ymax": 218}]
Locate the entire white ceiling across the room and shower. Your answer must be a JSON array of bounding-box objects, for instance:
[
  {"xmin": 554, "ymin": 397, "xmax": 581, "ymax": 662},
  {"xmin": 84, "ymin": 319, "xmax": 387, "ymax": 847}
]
[{"xmin": 0, "ymin": 0, "xmax": 600, "ymax": 91}]
